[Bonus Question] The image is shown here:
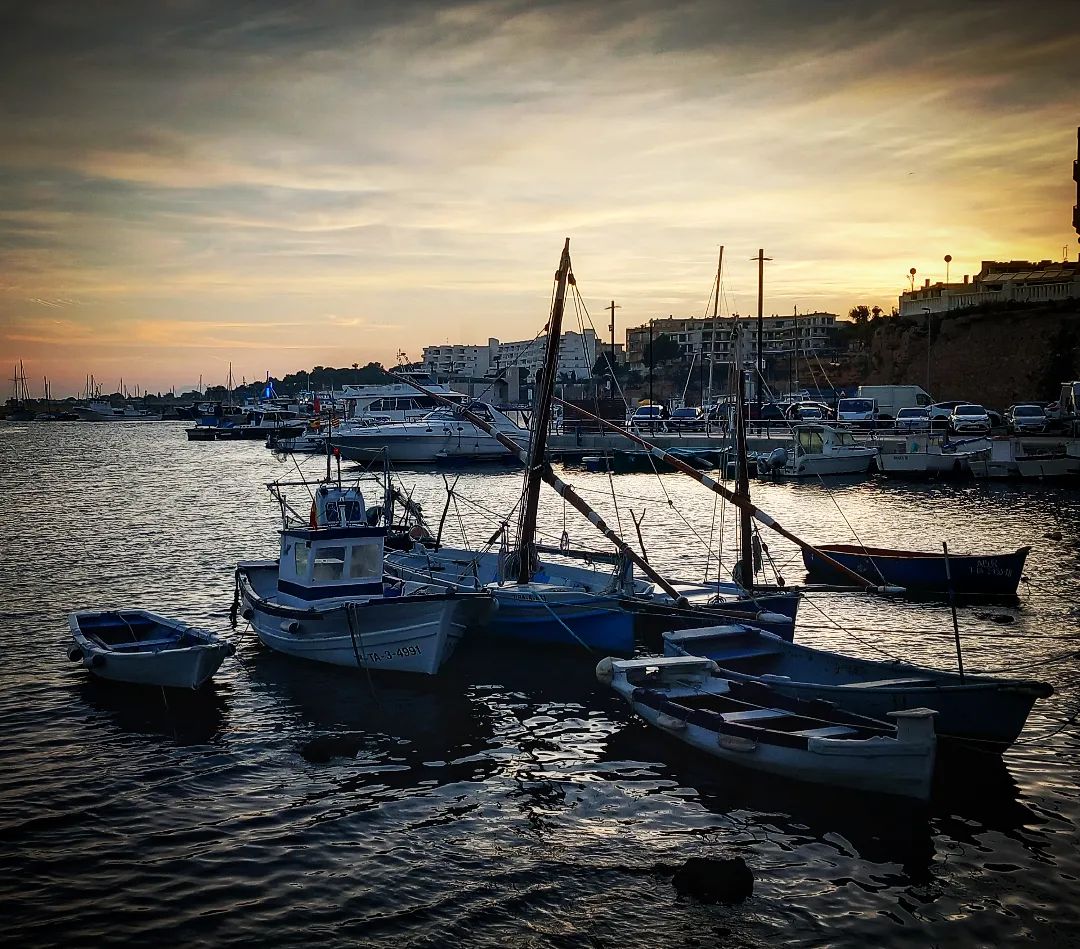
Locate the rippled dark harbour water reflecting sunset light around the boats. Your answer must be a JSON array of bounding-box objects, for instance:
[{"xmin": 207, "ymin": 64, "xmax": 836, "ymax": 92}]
[{"xmin": 0, "ymin": 422, "xmax": 1080, "ymax": 947}]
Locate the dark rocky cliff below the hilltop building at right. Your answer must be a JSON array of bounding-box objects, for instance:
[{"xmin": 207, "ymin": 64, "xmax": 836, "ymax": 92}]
[{"xmin": 861, "ymin": 300, "xmax": 1080, "ymax": 409}]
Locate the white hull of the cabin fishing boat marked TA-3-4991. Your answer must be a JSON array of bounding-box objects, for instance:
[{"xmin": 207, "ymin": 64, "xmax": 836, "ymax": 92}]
[{"xmin": 237, "ymin": 561, "xmax": 491, "ymax": 676}]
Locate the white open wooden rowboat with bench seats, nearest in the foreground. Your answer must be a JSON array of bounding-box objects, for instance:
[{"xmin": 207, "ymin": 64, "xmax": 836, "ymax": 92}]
[{"xmin": 596, "ymin": 656, "xmax": 936, "ymax": 800}]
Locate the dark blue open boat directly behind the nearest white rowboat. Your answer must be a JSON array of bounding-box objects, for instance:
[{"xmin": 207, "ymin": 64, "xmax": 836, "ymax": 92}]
[{"xmin": 663, "ymin": 624, "xmax": 1054, "ymax": 750}]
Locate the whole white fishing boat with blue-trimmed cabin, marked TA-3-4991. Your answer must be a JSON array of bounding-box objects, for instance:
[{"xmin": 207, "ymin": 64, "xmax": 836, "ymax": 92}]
[{"xmin": 234, "ymin": 481, "xmax": 494, "ymax": 675}]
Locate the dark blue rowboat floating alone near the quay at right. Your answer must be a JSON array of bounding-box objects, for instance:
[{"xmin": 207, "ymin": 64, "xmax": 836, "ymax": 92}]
[{"xmin": 802, "ymin": 544, "xmax": 1031, "ymax": 596}]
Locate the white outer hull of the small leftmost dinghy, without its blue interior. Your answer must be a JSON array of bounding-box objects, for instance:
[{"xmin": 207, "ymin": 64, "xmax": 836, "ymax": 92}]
[{"xmin": 68, "ymin": 610, "xmax": 235, "ymax": 689}]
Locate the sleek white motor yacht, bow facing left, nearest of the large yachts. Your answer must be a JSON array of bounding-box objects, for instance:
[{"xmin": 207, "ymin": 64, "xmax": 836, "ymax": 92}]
[{"xmin": 330, "ymin": 402, "xmax": 529, "ymax": 464}]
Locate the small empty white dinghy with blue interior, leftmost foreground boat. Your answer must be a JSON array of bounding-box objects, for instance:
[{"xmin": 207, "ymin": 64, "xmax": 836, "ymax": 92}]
[{"xmin": 68, "ymin": 610, "xmax": 237, "ymax": 689}]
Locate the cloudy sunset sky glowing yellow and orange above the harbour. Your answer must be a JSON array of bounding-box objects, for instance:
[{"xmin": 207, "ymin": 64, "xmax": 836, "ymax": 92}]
[{"xmin": 0, "ymin": 0, "xmax": 1080, "ymax": 398}]
